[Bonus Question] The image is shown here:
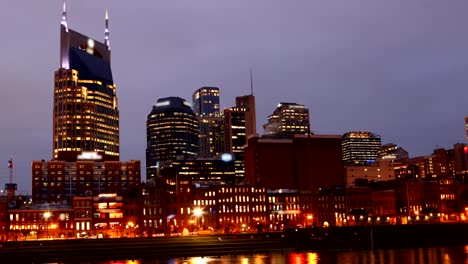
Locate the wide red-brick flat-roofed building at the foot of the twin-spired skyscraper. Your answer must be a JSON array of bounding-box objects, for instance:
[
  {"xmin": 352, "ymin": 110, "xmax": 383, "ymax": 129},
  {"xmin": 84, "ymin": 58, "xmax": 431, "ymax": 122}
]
[{"xmin": 32, "ymin": 157, "xmax": 141, "ymax": 204}]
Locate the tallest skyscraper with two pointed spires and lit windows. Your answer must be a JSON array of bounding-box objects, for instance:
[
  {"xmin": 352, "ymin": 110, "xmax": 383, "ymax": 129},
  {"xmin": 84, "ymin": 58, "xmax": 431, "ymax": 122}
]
[{"xmin": 53, "ymin": 4, "xmax": 119, "ymax": 160}]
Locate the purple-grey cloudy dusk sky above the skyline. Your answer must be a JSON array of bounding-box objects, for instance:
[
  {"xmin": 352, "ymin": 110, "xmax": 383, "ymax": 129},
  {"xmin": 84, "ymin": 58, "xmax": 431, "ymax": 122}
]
[{"xmin": 0, "ymin": 0, "xmax": 468, "ymax": 193}]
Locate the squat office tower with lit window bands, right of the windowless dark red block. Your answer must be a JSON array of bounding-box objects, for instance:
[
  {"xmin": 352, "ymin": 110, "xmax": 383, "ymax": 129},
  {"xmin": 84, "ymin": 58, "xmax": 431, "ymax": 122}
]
[{"xmin": 341, "ymin": 131, "xmax": 382, "ymax": 165}]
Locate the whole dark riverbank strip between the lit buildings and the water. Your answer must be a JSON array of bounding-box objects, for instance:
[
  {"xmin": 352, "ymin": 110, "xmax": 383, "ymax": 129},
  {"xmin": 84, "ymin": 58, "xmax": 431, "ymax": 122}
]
[{"xmin": 0, "ymin": 224, "xmax": 468, "ymax": 264}]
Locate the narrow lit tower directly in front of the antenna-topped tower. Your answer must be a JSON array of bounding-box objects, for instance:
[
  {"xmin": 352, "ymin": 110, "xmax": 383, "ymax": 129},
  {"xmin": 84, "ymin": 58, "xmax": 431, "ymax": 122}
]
[{"xmin": 223, "ymin": 107, "xmax": 247, "ymax": 182}]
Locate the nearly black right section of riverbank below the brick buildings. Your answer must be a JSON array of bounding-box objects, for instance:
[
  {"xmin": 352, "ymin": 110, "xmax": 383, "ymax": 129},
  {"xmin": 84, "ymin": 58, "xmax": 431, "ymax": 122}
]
[{"xmin": 284, "ymin": 223, "xmax": 468, "ymax": 250}]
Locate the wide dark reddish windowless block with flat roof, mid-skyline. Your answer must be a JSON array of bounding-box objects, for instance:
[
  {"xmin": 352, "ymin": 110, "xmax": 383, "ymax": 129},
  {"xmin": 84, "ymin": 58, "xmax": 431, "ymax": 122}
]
[{"xmin": 244, "ymin": 135, "xmax": 345, "ymax": 190}]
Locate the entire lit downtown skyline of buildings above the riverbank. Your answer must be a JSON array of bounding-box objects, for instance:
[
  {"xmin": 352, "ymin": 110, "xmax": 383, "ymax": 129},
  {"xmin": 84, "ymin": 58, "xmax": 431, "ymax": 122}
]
[{"xmin": 0, "ymin": 6, "xmax": 468, "ymax": 240}]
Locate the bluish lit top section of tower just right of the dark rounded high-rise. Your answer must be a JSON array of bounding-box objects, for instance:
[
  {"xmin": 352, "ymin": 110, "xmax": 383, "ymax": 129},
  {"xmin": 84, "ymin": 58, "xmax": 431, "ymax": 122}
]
[{"xmin": 192, "ymin": 87, "xmax": 219, "ymax": 117}]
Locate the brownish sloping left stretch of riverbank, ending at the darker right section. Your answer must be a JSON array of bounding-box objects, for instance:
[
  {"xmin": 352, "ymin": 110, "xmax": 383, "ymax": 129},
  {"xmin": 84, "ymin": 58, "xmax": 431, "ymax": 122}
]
[{"xmin": 0, "ymin": 233, "xmax": 294, "ymax": 264}]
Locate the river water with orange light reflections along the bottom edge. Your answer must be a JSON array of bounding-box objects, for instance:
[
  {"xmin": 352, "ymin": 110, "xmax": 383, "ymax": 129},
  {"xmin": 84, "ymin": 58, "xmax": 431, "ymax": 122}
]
[{"xmin": 89, "ymin": 246, "xmax": 468, "ymax": 264}]
